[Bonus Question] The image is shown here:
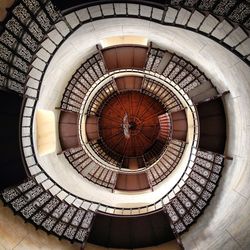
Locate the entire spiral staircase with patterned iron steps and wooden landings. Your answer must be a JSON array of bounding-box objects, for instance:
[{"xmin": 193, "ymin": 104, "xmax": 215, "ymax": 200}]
[{"xmin": 0, "ymin": 0, "xmax": 250, "ymax": 249}]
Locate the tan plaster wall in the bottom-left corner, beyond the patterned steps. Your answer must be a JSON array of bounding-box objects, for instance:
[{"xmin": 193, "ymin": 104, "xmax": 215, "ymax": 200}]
[{"xmin": 0, "ymin": 201, "xmax": 180, "ymax": 250}]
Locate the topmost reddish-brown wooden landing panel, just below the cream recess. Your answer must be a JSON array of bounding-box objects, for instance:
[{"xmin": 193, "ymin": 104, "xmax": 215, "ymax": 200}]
[{"xmin": 102, "ymin": 45, "xmax": 148, "ymax": 71}]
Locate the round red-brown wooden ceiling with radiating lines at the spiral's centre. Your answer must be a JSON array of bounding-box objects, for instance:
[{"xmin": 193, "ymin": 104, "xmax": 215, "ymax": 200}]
[{"xmin": 99, "ymin": 91, "xmax": 165, "ymax": 157}]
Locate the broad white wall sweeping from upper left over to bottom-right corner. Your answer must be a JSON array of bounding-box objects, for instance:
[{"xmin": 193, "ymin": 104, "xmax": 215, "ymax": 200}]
[{"xmin": 34, "ymin": 16, "xmax": 250, "ymax": 250}]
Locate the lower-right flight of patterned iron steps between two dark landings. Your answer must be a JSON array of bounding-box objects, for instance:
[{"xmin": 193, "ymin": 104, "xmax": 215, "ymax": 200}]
[{"xmin": 166, "ymin": 150, "xmax": 224, "ymax": 233}]
